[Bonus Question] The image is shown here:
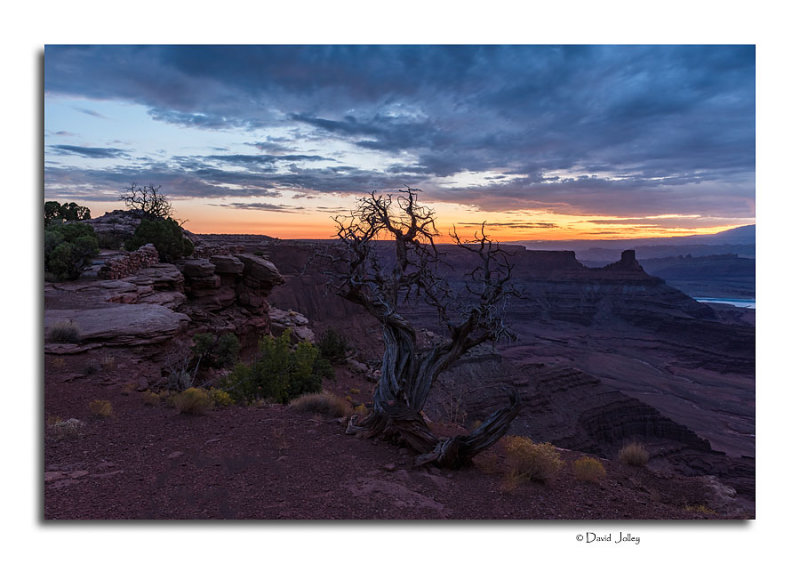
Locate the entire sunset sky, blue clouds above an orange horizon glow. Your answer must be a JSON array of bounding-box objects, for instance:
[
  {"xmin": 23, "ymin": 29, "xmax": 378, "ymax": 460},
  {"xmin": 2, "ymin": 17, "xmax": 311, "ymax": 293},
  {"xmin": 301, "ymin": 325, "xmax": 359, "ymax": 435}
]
[{"xmin": 43, "ymin": 45, "xmax": 756, "ymax": 240}]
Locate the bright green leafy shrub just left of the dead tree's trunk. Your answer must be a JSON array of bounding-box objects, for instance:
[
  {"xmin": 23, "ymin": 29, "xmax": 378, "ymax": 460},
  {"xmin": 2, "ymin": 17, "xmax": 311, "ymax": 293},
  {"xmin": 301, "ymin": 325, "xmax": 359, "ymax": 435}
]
[{"xmin": 223, "ymin": 330, "xmax": 322, "ymax": 403}]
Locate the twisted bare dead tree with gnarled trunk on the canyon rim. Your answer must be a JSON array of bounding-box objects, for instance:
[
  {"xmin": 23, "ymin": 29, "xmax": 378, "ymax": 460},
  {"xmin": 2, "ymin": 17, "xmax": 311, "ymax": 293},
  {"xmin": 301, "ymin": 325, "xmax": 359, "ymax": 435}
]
[{"xmin": 335, "ymin": 188, "xmax": 520, "ymax": 468}]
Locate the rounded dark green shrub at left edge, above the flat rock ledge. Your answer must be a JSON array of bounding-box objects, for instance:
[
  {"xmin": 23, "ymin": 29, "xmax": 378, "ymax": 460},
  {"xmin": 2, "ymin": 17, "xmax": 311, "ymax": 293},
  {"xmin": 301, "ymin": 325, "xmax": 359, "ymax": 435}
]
[{"xmin": 44, "ymin": 223, "xmax": 100, "ymax": 281}]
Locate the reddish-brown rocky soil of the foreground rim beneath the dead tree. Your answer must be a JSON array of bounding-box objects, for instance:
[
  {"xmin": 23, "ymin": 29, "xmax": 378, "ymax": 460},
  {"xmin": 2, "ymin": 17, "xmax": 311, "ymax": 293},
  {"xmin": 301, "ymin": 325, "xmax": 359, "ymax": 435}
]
[{"xmin": 43, "ymin": 349, "xmax": 752, "ymax": 520}]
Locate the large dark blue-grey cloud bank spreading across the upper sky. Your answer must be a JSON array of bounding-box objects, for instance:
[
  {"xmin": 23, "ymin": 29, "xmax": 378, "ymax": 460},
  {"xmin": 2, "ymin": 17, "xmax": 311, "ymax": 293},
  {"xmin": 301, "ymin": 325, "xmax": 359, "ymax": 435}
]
[{"xmin": 45, "ymin": 46, "xmax": 755, "ymax": 217}]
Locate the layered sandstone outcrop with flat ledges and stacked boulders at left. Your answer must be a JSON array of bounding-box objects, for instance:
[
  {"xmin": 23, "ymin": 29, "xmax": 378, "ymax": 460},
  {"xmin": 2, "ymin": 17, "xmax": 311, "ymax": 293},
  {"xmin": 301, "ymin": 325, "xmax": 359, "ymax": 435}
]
[{"xmin": 44, "ymin": 236, "xmax": 294, "ymax": 360}]
